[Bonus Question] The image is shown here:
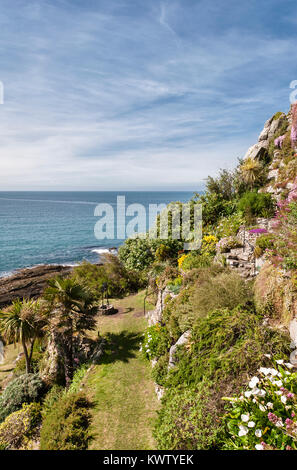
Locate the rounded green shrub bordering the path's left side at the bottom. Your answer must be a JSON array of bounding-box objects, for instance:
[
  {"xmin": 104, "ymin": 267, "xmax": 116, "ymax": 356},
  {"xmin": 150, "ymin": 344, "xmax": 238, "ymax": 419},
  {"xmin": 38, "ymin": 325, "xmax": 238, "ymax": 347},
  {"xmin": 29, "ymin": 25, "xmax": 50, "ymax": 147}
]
[{"xmin": 40, "ymin": 393, "xmax": 91, "ymax": 450}]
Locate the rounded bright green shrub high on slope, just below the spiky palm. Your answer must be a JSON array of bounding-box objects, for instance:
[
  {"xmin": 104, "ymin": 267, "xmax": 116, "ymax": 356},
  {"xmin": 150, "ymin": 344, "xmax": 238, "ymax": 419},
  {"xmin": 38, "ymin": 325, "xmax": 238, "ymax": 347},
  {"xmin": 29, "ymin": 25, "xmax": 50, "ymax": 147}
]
[{"xmin": 238, "ymin": 192, "xmax": 275, "ymax": 221}]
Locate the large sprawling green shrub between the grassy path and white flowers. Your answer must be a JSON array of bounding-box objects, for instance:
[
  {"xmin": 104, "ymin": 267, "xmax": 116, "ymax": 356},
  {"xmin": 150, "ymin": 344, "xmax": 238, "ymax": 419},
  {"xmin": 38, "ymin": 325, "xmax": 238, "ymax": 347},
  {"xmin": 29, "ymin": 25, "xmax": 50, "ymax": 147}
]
[{"xmin": 155, "ymin": 304, "xmax": 289, "ymax": 450}]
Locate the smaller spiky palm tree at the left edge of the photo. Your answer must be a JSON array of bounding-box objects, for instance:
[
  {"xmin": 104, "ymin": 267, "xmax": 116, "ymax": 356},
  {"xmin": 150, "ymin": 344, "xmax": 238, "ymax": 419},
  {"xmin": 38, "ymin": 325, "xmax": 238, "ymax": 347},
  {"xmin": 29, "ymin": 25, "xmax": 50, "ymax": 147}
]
[{"xmin": 0, "ymin": 299, "xmax": 46, "ymax": 374}]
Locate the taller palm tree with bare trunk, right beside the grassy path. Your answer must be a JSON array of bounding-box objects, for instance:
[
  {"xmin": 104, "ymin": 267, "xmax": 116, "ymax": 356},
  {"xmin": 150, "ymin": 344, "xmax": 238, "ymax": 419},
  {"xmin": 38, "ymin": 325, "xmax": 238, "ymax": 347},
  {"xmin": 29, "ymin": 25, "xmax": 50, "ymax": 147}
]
[{"xmin": 44, "ymin": 277, "xmax": 97, "ymax": 387}]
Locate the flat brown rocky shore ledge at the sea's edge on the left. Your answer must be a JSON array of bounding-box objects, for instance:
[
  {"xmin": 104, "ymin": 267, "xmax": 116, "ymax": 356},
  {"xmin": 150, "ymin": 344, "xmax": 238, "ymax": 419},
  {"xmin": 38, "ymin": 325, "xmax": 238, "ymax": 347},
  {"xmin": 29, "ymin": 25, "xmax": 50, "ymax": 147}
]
[{"xmin": 0, "ymin": 265, "xmax": 73, "ymax": 308}]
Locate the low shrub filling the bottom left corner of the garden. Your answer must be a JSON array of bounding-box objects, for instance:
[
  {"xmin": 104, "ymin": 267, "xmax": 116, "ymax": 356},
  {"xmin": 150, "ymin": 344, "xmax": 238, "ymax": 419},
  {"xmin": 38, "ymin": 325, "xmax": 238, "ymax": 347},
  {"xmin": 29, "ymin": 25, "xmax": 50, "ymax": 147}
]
[{"xmin": 0, "ymin": 403, "xmax": 41, "ymax": 450}]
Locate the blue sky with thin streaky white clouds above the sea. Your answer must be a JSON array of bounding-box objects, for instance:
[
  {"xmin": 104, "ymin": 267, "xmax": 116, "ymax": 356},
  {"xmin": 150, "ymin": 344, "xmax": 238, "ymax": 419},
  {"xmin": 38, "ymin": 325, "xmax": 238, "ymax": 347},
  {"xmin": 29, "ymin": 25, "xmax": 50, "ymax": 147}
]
[{"xmin": 0, "ymin": 0, "xmax": 297, "ymax": 191}]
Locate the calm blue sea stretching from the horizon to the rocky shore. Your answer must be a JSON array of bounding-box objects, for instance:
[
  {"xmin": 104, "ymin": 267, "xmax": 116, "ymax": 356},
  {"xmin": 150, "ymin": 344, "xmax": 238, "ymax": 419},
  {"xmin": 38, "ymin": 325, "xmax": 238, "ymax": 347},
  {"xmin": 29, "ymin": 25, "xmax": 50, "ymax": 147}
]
[{"xmin": 0, "ymin": 191, "xmax": 193, "ymax": 276}]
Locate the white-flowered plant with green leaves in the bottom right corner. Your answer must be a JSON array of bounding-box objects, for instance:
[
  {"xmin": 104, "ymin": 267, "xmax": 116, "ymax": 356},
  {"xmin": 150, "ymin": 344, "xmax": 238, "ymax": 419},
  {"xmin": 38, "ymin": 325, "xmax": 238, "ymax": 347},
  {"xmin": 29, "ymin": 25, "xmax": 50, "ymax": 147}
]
[{"xmin": 223, "ymin": 359, "xmax": 297, "ymax": 450}]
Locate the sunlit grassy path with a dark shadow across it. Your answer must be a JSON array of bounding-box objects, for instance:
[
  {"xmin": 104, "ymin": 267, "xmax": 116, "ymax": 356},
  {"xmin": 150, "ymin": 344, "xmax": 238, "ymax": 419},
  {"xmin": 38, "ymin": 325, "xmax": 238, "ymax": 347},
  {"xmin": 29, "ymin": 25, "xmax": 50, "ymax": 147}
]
[{"xmin": 84, "ymin": 293, "xmax": 158, "ymax": 450}]
